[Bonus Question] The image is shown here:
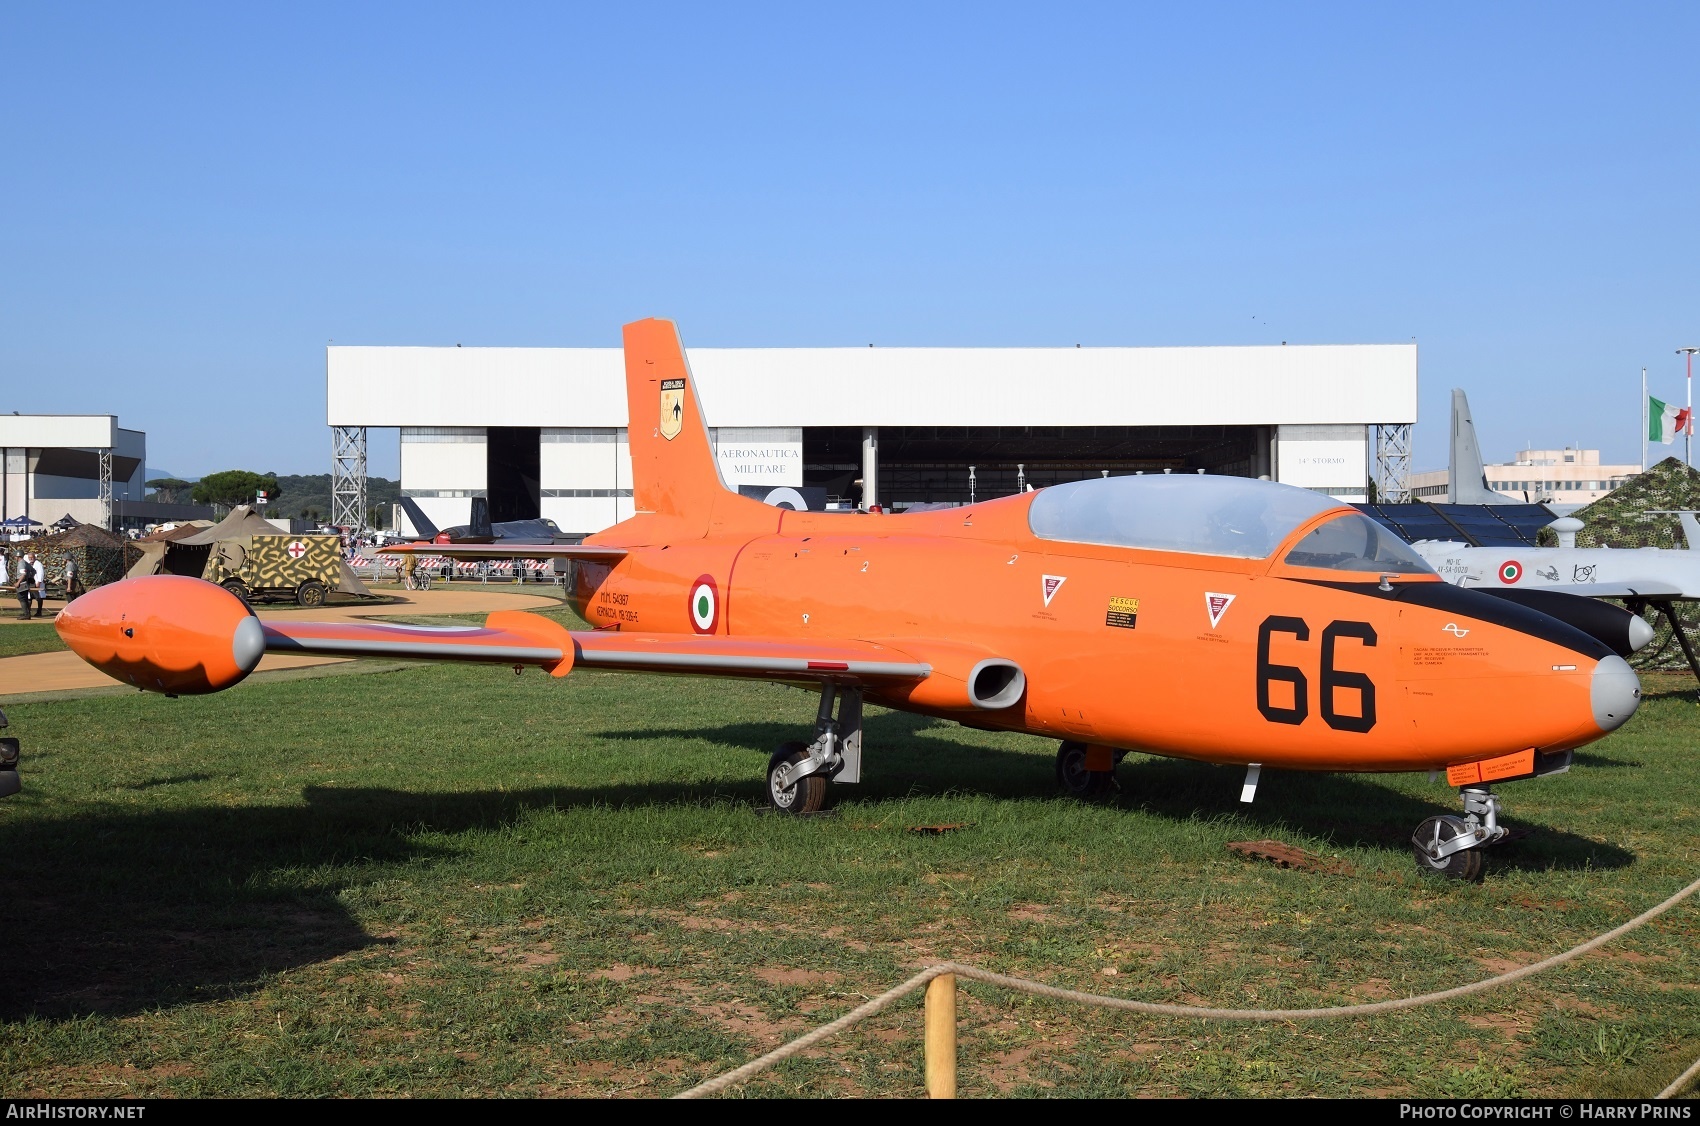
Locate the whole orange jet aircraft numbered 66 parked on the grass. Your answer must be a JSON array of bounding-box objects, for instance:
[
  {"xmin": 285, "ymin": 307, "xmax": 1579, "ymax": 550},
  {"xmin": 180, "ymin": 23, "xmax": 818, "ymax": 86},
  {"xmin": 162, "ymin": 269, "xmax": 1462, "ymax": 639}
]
[{"xmin": 58, "ymin": 320, "xmax": 1641, "ymax": 878}]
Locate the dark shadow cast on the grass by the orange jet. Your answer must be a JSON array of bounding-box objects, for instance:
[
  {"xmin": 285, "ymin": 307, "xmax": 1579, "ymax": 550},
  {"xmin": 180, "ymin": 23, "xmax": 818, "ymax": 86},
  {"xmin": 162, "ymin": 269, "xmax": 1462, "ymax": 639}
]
[{"xmin": 0, "ymin": 713, "xmax": 1634, "ymax": 1021}]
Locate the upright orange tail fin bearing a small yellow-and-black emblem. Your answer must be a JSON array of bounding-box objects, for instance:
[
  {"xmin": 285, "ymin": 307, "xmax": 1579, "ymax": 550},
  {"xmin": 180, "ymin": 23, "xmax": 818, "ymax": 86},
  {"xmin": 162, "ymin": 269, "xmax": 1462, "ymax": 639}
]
[{"xmin": 624, "ymin": 318, "xmax": 741, "ymax": 531}]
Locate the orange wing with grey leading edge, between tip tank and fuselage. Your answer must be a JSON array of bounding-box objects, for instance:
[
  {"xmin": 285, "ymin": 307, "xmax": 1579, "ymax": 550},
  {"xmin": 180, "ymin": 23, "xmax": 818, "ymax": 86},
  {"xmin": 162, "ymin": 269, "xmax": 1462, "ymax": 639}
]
[{"xmin": 264, "ymin": 611, "xmax": 932, "ymax": 684}]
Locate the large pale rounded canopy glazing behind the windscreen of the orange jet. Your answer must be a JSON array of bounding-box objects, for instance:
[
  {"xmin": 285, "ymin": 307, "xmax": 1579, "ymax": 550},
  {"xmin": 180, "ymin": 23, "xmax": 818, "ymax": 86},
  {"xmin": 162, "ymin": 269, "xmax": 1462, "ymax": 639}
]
[{"xmin": 1027, "ymin": 475, "xmax": 1360, "ymax": 560}]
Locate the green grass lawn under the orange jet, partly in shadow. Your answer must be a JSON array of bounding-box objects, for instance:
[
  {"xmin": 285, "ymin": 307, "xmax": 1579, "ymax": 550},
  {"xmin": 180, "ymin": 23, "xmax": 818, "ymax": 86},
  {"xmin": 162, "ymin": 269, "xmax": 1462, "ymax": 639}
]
[{"xmin": 0, "ymin": 629, "xmax": 1700, "ymax": 1097}]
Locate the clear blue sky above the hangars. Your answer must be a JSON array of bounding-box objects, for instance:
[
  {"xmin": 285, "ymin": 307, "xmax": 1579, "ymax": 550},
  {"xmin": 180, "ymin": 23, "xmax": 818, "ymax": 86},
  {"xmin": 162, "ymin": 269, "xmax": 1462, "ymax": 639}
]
[{"xmin": 0, "ymin": 3, "xmax": 1700, "ymax": 475}]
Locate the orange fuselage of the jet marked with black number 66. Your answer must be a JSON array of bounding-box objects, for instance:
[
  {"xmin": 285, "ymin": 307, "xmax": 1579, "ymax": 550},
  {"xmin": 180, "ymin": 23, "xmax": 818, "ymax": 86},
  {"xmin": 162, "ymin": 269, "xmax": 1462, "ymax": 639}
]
[{"xmin": 573, "ymin": 495, "xmax": 1615, "ymax": 771}]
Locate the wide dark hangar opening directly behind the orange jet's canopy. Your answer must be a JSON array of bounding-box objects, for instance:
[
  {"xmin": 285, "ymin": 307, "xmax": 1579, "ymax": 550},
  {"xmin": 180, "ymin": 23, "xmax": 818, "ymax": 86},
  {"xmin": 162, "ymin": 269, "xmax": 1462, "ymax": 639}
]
[{"xmin": 802, "ymin": 425, "xmax": 1275, "ymax": 507}]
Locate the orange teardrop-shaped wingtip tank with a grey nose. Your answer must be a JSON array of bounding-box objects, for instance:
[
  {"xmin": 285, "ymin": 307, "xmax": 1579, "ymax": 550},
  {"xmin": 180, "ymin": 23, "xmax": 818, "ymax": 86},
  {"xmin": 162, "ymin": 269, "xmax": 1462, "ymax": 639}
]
[{"xmin": 53, "ymin": 575, "xmax": 265, "ymax": 696}]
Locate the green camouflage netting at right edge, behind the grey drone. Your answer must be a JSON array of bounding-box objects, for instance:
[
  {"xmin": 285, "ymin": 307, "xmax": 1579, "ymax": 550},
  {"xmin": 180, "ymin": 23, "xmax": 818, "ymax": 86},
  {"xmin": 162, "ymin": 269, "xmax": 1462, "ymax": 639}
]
[{"xmin": 1540, "ymin": 458, "xmax": 1700, "ymax": 670}]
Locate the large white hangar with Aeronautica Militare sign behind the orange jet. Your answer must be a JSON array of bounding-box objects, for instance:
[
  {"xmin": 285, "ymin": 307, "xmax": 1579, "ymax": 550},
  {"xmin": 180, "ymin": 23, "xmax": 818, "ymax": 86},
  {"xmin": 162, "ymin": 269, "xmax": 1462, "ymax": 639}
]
[{"xmin": 326, "ymin": 344, "xmax": 1416, "ymax": 534}]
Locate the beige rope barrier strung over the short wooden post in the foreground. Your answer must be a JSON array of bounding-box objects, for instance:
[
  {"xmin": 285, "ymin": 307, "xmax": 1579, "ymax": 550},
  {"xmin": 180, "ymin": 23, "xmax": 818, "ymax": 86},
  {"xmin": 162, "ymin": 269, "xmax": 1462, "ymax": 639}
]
[{"xmin": 675, "ymin": 879, "xmax": 1700, "ymax": 1099}]
